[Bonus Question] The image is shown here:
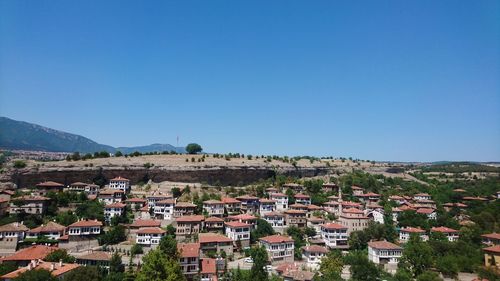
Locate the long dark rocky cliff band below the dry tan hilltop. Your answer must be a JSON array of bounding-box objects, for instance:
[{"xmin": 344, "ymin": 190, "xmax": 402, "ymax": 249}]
[{"xmin": 4, "ymin": 166, "xmax": 328, "ymax": 188}]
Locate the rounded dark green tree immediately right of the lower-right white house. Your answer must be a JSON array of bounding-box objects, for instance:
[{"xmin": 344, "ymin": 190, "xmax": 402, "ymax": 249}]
[{"xmin": 400, "ymin": 235, "xmax": 432, "ymax": 277}]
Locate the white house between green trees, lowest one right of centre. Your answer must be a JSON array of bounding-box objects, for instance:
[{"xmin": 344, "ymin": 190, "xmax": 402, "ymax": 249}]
[{"xmin": 368, "ymin": 241, "xmax": 403, "ymax": 273}]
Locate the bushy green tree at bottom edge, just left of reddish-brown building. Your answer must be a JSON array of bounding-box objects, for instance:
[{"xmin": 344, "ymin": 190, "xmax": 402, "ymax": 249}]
[{"xmin": 136, "ymin": 249, "xmax": 186, "ymax": 281}]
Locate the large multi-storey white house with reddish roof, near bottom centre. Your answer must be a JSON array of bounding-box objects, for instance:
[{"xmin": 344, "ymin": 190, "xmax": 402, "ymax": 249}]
[{"xmin": 259, "ymin": 234, "xmax": 294, "ymax": 263}]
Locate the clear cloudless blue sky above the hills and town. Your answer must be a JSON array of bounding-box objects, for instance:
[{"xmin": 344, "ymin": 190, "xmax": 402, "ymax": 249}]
[{"xmin": 0, "ymin": 0, "xmax": 500, "ymax": 161}]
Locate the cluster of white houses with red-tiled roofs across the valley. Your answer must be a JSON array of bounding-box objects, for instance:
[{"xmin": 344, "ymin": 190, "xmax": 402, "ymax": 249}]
[{"xmin": 0, "ymin": 177, "xmax": 500, "ymax": 281}]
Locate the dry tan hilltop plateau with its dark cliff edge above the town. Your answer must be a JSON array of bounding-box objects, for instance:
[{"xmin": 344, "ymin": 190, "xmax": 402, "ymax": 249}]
[{"xmin": 0, "ymin": 154, "xmax": 404, "ymax": 187}]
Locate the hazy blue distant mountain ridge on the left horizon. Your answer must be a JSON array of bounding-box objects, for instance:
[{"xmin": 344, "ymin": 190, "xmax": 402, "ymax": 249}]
[{"xmin": 0, "ymin": 117, "xmax": 185, "ymax": 154}]
